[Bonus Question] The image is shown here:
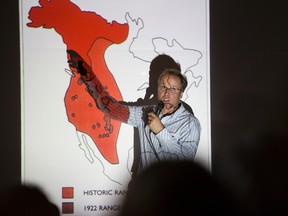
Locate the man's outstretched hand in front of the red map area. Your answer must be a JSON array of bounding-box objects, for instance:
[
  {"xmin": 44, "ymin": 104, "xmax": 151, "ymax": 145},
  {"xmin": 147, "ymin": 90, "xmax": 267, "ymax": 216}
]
[{"xmin": 67, "ymin": 50, "xmax": 95, "ymax": 81}]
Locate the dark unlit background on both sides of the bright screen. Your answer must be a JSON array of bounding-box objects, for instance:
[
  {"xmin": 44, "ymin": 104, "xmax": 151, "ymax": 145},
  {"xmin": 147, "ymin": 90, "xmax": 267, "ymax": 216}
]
[{"xmin": 0, "ymin": 0, "xmax": 288, "ymax": 215}]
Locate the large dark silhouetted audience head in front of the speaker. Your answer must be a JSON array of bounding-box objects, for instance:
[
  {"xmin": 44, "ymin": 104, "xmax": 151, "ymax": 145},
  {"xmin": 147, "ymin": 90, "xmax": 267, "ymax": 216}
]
[{"xmin": 120, "ymin": 161, "xmax": 235, "ymax": 216}]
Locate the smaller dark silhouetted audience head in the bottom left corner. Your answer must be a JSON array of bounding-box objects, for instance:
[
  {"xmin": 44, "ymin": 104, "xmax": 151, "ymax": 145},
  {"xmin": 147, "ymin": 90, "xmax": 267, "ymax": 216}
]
[{"xmin": 0, "ymin": 185, "xmax": 60, "ymax": 216}]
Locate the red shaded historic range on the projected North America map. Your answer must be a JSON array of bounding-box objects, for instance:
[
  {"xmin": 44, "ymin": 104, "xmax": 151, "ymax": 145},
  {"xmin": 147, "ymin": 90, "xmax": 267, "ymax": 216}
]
[{"xmin": 27, "ymin": 0, "xmax": 129, "ymax": 164}]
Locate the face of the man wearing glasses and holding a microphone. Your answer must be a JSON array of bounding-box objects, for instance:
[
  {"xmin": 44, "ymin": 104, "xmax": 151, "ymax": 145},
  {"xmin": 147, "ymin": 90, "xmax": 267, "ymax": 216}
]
[{"xmin": 158, "ymin": 75, "xmax": 183, "ymax": 108}]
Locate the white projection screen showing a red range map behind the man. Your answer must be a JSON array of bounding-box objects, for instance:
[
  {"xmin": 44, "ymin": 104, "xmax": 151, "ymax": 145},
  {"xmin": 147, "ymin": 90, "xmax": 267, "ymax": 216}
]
[{"xmin": 19, "ymin": 0, "xmax": 211, "ymax": 215}]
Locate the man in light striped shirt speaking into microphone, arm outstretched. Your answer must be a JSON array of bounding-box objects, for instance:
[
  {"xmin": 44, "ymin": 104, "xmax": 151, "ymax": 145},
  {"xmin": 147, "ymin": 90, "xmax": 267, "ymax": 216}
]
[{"xmin": 67, "ymin": 50, "xmax": 201, "ymax": 177}]
